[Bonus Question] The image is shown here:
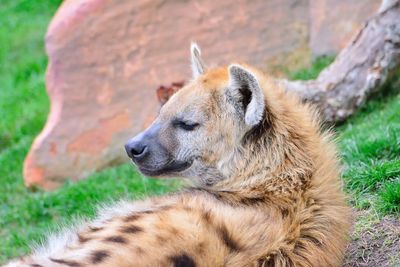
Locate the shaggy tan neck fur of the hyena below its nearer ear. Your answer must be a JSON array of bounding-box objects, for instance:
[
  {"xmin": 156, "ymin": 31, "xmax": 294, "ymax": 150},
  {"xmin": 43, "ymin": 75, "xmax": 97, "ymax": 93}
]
[{"xmin": 211, "ymin": 115, "xmax": 315, "ymax": 206}]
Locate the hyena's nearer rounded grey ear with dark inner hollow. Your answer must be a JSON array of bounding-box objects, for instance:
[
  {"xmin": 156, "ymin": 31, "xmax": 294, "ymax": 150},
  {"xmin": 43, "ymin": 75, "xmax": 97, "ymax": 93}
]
[{"xmin": 228, "ymin": 64, "xmax": 265, "ymax": 126}]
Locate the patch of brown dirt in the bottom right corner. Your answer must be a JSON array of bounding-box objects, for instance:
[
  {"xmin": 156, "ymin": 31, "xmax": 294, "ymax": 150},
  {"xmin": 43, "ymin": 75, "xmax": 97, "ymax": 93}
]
[{"xmin": 343, "ymin": 211, "xmax": 400, "ymax": 267}]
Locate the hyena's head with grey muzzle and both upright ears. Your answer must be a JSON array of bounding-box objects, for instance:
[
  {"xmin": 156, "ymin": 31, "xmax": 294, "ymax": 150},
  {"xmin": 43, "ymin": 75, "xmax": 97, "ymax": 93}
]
[{"xmin": 125, "ymin": 44, "xmax": 280, "ymax": 186}]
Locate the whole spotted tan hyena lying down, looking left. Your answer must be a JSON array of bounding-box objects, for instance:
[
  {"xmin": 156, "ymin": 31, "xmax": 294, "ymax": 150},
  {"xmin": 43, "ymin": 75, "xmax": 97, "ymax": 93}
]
[{"xmin": 8, "ymin": 44, "xmax": 350, "ymax": 267}]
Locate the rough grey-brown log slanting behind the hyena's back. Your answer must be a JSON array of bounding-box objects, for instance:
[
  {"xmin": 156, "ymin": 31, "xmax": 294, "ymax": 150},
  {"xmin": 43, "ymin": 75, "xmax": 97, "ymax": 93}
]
[{"xmin": 279, "ymin": 0, "xmax": 400, "ymax": 122}]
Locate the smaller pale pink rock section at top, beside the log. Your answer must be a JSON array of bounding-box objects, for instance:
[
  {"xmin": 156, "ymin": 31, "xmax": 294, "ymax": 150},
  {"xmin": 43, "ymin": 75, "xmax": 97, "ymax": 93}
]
[{"xmin": 310, "ymin": 0, "xmax": 382, "ymax": 56}]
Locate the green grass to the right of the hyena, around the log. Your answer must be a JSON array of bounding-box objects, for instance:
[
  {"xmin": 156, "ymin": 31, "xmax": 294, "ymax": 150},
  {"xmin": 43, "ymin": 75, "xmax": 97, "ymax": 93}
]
[{"xmin": 288, "ymin": 57, "xmax": 400, "ymax": 215}]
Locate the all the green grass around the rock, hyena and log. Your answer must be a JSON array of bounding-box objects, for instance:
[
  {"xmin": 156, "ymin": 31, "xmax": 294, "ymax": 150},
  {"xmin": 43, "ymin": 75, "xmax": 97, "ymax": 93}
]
[{"xmin": 0, "ymin": 0, "xmax": 400, "ymax": 263}]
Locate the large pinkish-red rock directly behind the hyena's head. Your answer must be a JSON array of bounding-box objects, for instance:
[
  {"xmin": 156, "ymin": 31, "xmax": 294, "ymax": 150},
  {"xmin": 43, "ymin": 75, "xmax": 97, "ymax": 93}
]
[{"xmin": 24, "ymin": 0, "xmax": 309, "ymax": 189}]
